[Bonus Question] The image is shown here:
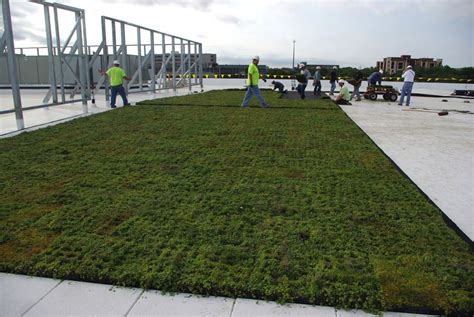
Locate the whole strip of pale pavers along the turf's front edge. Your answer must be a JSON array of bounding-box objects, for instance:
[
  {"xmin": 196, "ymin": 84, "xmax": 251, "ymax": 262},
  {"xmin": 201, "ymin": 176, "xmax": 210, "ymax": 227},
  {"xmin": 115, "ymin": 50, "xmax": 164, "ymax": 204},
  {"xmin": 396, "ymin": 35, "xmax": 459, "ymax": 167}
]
[{"xmin": 0, "ymin": 273, "xmax": 440, "ymax": 317}]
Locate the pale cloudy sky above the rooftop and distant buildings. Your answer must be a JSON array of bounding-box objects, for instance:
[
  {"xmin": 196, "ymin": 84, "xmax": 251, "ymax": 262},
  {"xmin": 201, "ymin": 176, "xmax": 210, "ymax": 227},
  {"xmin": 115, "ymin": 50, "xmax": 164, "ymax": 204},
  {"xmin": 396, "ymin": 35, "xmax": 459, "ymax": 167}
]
[{"xmin": 0, "ymin": 0, "xmax": 474, "ymax": 67}]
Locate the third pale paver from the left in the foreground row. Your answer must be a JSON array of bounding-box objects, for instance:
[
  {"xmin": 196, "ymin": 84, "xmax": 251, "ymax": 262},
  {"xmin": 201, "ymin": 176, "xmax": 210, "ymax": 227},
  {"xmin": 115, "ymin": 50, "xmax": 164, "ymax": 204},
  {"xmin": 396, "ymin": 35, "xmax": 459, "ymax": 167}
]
[{"xmin": 127, "ymin": 291, "xmax": 234, "ymax": 317}]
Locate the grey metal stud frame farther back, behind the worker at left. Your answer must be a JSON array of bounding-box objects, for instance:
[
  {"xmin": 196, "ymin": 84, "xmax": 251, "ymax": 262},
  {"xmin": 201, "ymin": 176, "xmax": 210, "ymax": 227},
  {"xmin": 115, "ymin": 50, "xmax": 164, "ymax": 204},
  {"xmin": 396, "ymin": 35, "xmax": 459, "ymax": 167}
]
[{"xmin": 88, "ymin": 16, "xmax": 203, "ymax": 101}]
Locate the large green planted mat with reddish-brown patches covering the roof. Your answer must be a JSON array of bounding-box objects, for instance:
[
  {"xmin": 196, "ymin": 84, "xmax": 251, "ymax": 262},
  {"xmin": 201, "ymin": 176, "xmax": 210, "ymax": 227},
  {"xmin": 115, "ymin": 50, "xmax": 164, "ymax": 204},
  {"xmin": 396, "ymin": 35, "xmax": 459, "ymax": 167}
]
[{"xmin": 0, "ymin": 91, "xmax": 474, "ymax": 315}]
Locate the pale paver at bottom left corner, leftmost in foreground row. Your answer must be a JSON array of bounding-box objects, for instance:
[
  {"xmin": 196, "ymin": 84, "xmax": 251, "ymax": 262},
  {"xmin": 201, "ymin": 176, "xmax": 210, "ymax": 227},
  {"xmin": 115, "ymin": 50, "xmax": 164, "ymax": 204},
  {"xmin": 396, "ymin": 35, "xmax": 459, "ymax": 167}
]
[{"xmin": 0, "ymin": 273, "xmax": 61, "ymax": 317}]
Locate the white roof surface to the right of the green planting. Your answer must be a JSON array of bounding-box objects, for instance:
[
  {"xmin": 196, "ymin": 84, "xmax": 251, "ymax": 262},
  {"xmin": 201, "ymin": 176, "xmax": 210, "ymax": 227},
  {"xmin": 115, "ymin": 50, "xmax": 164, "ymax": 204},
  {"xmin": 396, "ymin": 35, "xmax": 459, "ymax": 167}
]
[{"xmin": 341, "ymin": 97, "xmax": 474, "ymax": 240}]
